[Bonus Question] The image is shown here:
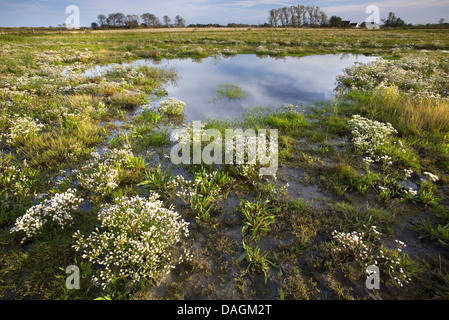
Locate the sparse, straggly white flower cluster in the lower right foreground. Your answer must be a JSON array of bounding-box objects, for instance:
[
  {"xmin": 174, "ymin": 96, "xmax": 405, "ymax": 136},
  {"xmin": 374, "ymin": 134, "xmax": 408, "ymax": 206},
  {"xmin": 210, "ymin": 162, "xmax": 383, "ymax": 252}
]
[{"xmin": 332, "ymin": 226, "xmax": 411, "ymax": 287}]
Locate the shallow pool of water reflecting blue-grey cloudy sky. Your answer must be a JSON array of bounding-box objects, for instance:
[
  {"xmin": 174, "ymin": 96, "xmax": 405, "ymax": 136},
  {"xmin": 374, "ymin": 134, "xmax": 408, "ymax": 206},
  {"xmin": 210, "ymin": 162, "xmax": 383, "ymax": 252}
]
[{"xmin": 89, "ymin": 54, "xmax": 377, "ymax": 121}]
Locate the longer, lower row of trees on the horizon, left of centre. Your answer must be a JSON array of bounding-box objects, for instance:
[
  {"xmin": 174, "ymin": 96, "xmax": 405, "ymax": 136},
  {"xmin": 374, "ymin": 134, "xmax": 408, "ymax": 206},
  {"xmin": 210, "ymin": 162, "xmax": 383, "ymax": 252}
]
[{"xmin": 91, "ymin": 12, "xmax": 186, "ymax": 29}]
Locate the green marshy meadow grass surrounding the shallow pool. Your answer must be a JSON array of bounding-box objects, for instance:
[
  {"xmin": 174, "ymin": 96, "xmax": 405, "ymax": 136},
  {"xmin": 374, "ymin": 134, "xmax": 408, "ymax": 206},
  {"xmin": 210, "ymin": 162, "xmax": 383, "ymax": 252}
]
[{"xmin": 0, "ymin": 28, "xmax": 449, "ymax": 299}]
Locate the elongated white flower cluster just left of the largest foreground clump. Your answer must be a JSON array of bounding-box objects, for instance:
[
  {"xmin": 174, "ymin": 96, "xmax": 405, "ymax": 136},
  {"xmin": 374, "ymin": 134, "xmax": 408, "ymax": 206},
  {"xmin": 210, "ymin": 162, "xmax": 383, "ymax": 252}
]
[{"xmin": 10, "ymin": 189, "xmax": 83, "ymax": 242}]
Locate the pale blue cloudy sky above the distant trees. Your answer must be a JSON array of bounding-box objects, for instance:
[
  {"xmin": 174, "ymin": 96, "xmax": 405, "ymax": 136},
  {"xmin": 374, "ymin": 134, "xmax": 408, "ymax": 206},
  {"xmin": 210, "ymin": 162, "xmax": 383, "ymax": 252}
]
[{"xmin": 0, "ymin": 0, "xmax": 449, "ymax": 27}]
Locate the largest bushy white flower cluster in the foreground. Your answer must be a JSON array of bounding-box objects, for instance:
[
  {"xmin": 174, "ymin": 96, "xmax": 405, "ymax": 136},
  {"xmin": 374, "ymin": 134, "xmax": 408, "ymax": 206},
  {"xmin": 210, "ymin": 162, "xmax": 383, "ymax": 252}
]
[{"xmin": 74, "ymin": 193, "xmax": 190, "ymax": 288}]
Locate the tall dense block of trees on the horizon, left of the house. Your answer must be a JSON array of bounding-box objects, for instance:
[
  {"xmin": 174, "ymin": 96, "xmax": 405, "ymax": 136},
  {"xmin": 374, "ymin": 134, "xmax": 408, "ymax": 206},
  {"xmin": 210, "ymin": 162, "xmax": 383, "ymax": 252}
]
[{"xmin": 268, "ymin": 5, "xmax": 329, "ymax": 28}]
